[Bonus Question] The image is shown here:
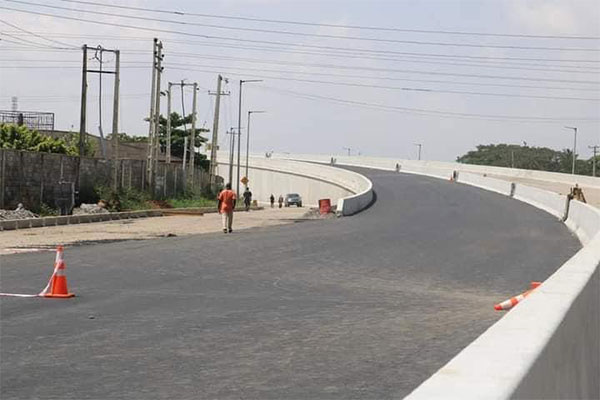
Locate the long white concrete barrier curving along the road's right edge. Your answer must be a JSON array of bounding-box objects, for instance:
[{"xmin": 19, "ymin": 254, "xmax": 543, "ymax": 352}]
[{"xmin": 274, "ymin": 152, "xmax": 600, "ymax": 400}]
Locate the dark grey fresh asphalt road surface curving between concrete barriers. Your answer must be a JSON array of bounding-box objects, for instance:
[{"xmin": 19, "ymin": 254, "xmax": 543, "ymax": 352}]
[{"xmin": 0, "ymin": 167, "xmax": 579, "ymax": 400}]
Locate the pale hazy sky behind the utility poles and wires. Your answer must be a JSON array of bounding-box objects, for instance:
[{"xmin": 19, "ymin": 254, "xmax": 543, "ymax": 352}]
[{"xmin": 0, "ymin": 0, "xmax": 600, "ymax": 161}]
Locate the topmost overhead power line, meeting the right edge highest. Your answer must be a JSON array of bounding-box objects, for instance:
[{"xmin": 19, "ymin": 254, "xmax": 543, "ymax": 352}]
[{"xmin": 56, "ymin": 0, "xmax": 600, "ymax": 40}]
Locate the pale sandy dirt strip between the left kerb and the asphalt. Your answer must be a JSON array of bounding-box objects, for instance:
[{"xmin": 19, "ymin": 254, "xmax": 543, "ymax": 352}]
[{"xmin": 0, "ymin": 207, "xmax": 309, "ymax": 255}]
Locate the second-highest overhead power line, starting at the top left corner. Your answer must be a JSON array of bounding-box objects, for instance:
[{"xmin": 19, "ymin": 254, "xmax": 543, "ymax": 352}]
[{"xmin": 5, "ymin": 0, "xmax": 600, "ymax": 52}]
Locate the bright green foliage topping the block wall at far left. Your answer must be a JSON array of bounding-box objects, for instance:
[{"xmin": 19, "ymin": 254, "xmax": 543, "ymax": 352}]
[{"xmin": 0, "ymin": 124, "xmax": 78, "ymax": 156}]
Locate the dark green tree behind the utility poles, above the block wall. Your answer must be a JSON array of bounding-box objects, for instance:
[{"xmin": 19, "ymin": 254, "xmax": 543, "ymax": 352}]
[{"xmin": 159, "ymin": 112, "xmax": 210, "ymax": 170}]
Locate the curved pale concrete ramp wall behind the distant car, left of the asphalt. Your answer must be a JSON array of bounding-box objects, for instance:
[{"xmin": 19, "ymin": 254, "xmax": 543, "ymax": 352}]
[{"xmin": 217, "ymin": 153, "xmax": 372, "ymax": 215}]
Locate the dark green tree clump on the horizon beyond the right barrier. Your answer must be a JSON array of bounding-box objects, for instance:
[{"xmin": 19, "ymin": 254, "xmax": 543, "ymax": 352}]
[{"xmin": 456, "ymin": 144, "xmax": 592, "ymax": 175}]
